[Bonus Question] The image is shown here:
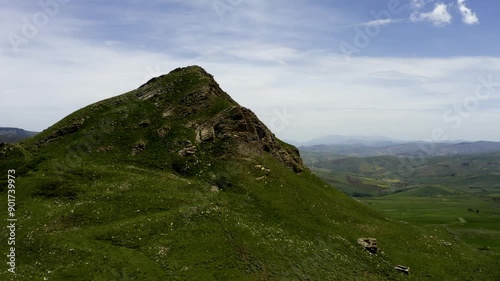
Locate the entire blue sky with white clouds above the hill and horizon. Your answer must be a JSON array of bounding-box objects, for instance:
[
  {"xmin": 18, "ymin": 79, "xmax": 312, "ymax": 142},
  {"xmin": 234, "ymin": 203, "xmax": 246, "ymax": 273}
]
[{"xmin": 0, "ymin": 0, "xmax": 500, "ymax": 142}]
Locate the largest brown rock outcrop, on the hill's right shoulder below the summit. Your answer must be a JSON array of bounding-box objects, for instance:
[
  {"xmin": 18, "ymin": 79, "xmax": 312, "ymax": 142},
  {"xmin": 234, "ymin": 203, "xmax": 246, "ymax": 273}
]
[{"xmin": 196, "ymin": 106, "xmax": 305, "ymax": 173}]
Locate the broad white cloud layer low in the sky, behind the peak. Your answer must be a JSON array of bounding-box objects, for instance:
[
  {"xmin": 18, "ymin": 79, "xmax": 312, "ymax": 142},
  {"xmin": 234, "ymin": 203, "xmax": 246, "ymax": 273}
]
[{"xmin": 0, "ymin": 34, "xmax": 500, "ymax": 141}]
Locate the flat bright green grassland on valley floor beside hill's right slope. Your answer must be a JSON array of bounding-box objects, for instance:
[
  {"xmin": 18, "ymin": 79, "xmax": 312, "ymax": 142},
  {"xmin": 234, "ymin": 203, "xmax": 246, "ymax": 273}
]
[{"xmin": 363, "ymin": 193, "xmax": 500, "ymax": 256}]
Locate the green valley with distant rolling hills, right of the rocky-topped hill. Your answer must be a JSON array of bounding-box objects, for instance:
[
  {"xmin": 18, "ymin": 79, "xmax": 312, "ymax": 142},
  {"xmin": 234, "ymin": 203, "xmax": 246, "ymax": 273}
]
[{"xmin": 301, "ymin": 145, "xmax": 500, "ymax": 257}]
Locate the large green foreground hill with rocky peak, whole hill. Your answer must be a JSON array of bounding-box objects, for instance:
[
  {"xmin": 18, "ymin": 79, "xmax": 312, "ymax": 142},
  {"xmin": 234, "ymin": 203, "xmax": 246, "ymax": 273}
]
[{"xmin": 0, "ymin": 66, "xmax": 500, "ymax": 280}]
